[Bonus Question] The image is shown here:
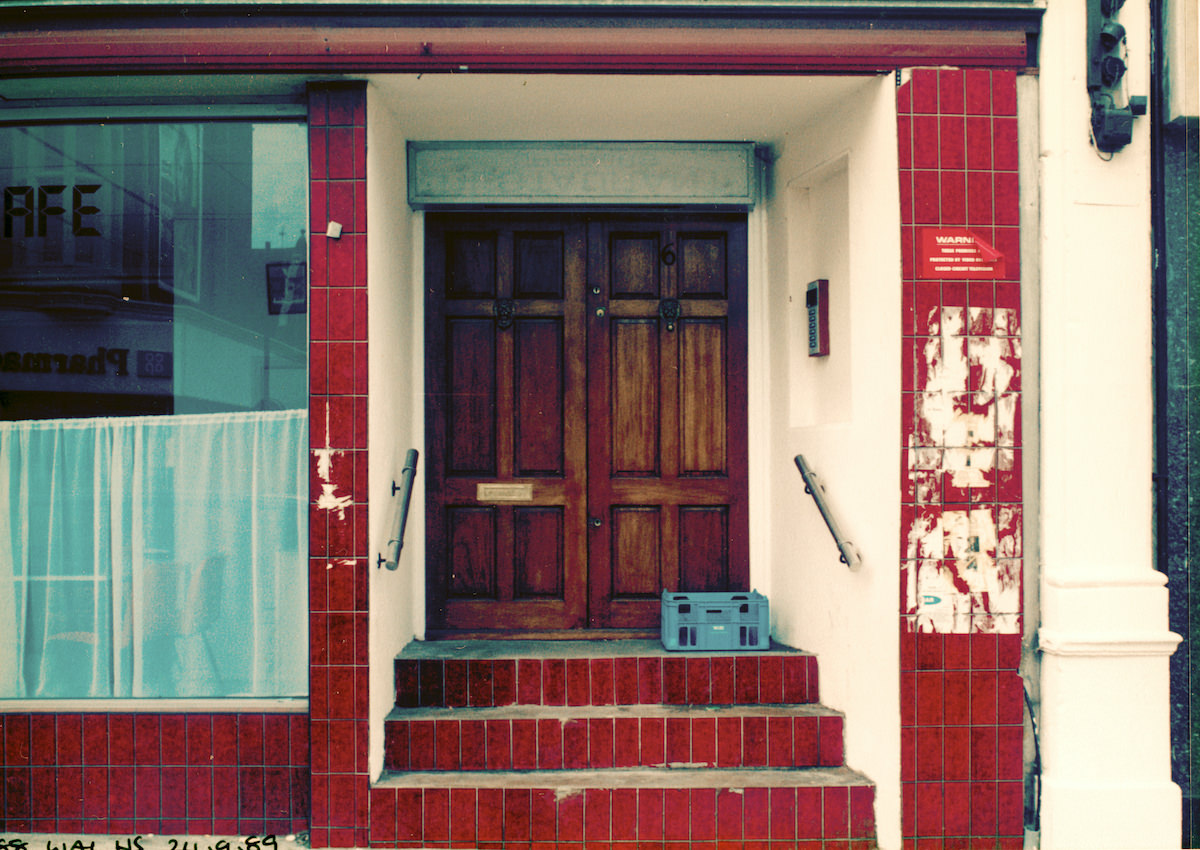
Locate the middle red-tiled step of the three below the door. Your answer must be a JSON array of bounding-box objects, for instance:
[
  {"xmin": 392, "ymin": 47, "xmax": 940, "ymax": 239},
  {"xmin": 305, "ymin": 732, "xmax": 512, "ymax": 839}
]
[{"xmin": 384, "ymin": 705, "xmax": 842, "ymax": 771}]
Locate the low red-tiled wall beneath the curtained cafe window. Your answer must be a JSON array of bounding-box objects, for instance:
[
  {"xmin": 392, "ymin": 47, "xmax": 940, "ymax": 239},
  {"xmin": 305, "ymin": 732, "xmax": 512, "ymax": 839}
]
[{"xmin": 0, "ymin": 713, "xmax": 308, "ymax": 836}]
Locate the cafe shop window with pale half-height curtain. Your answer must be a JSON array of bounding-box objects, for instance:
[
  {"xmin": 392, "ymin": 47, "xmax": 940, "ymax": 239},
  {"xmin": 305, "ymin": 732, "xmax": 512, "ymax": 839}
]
[{"xmin": 0, "ymin": 121, "xmax": 308, "ymax": 699}]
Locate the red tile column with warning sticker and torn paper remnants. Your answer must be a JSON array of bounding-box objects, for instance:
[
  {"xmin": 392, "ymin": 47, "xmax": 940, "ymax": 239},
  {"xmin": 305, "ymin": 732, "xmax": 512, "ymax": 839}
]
[{"xmin": 898, "ymin": 70, "xmax": 1024, "ymax": 848}]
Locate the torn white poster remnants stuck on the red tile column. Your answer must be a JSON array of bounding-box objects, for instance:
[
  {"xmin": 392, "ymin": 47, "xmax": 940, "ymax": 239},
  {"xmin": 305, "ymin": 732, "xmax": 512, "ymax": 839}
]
[{"xmin": 902, "ymin": 295, "xmax": 1021, "ymax": 634}]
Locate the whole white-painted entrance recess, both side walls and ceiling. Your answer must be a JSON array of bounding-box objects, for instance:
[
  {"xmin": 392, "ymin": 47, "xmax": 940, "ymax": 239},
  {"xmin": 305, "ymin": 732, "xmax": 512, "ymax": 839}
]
[{"xmin": 367, "ymin": 74, "xmax": 900, "ymax": 850}]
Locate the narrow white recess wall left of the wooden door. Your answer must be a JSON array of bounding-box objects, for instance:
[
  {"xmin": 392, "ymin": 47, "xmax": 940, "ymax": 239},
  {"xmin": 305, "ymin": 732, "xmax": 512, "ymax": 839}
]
[{"xmin": 367, "ymin": 85, "xmax": 425, "ymax": 777}]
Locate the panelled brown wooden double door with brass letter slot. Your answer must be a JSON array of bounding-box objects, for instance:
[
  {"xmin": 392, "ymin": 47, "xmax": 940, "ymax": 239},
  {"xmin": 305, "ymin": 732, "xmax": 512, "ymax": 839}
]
[{"xmin": 425, "ymin": 213, "xmax": 749, "ymax": 634}]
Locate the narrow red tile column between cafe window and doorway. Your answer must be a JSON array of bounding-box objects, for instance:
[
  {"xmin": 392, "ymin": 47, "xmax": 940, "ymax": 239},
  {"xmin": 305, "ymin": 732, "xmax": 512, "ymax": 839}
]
[{"xmin": 308, "ymin": 83, "xmax": 368, "ymax": 846}]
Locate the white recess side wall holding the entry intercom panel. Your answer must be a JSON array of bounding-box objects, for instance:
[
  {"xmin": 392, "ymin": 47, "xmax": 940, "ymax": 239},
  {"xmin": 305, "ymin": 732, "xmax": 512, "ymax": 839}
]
[{"xmin": 752, "ymin": 77, "xmax": 901, "ymax": 848}]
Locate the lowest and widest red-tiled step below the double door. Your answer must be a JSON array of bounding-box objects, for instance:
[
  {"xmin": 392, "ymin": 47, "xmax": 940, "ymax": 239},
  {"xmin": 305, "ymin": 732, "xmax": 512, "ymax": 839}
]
[{"xmin": 371, "ymin": 767, "xmax": 875, "ymax": 850}]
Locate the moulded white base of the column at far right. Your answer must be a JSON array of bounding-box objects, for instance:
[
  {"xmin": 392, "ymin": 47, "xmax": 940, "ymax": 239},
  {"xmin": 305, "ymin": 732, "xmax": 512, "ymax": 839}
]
[{"xmin": 1038, "ymin": 570, "xmax": 1182, "ymax": 850}]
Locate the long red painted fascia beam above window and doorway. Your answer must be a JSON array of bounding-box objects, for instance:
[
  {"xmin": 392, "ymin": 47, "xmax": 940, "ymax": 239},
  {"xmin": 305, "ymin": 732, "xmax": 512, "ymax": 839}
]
[{"xmin": 0, "ymin": 23, "xmax": 1030, "ymax": 74}]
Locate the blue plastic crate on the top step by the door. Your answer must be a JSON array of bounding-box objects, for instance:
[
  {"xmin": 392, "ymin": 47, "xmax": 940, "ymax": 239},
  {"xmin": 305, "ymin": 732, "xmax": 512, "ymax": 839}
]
[{"xmin": 662, "ymin": 591, "xmax": 770, "ymax": 651}]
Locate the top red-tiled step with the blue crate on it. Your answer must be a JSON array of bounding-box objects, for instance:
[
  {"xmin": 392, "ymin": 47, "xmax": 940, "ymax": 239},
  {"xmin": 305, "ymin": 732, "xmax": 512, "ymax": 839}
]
[{"xmin": 395, "ymin": 641, "xmax": 818, "ymax": 708}]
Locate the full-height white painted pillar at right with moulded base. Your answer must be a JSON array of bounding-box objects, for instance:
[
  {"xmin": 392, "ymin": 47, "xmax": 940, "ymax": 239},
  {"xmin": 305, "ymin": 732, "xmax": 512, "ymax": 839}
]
[{"xmin": 1025, "ymin": 0, "xmax": 1181, "ymax": 849}]
